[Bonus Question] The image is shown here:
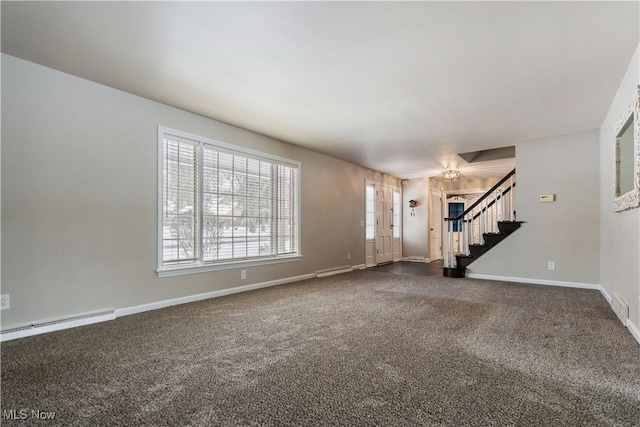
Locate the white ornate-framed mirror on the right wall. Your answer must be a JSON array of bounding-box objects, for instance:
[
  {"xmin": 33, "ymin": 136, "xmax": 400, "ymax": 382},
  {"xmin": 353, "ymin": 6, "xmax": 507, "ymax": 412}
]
[{"xmin": 613, "ymin": 86, "xmax": 640, "ymax": 212}]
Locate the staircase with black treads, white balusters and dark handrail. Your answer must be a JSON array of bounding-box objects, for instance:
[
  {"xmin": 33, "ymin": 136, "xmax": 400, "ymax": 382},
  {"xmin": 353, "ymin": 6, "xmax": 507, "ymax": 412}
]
[{"xmin": 443, "ymin": 169, "xmax": 522, "ymax": 277}]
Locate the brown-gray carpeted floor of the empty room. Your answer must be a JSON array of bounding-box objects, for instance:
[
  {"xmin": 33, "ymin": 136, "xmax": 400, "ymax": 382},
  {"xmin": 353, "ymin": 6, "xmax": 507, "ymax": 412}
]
[{"xmin": 1, "ymin": 270, "xmax": 640, "ymax": 426}]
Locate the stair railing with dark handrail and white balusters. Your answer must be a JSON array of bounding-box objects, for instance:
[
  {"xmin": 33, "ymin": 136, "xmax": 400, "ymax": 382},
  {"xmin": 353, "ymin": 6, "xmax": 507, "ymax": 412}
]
[{"xmin": 443, "ymin": 169, "xmax": 516, "ymax": 268}]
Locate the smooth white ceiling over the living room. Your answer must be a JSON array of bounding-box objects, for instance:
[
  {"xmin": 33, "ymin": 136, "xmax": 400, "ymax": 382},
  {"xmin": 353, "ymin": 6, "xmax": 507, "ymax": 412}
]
[{"xmin": 1, "ymin": 1, "xmax": 640, "ymax": 178}]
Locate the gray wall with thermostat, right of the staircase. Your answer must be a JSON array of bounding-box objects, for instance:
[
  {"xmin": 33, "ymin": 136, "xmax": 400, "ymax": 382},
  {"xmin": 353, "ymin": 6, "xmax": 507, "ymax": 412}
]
[{"xmin": 468, "ymin": 131, "xmax": 600, "ymax": 285}]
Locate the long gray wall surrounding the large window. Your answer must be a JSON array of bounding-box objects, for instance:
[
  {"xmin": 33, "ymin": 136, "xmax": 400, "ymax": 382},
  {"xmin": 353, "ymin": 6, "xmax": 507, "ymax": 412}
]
[{"xmin": 1, "ymin": 55, "xmax": 399, "ymax": 328}]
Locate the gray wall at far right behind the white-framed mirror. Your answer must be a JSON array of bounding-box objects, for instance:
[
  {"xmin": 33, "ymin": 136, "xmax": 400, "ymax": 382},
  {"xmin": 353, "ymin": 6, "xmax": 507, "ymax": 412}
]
[{"xmin": 600, "ymin": 44, "xmax": 640, "ymax": 329}]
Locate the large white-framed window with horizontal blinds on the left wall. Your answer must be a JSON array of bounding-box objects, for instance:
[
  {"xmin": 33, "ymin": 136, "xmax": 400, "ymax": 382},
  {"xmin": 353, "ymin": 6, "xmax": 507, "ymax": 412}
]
[{"xmin": 158, "ymin": 128, "xmax": 300, "ymax": 276}]
